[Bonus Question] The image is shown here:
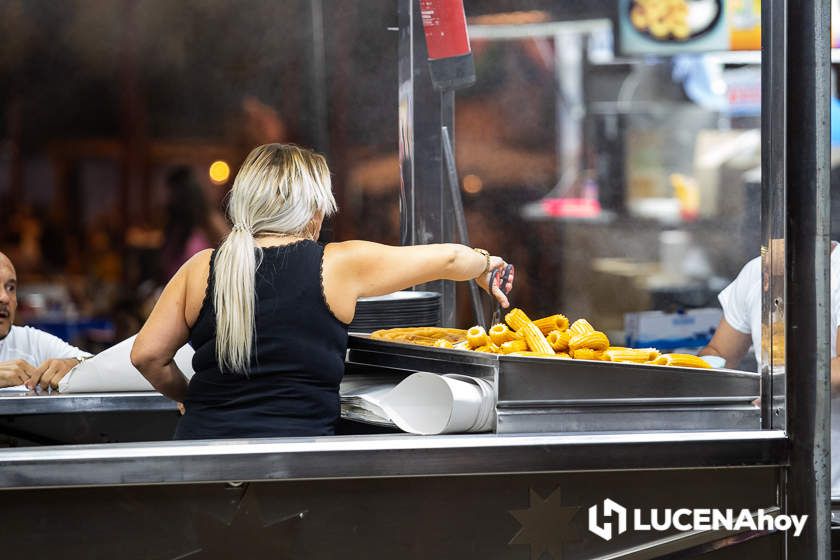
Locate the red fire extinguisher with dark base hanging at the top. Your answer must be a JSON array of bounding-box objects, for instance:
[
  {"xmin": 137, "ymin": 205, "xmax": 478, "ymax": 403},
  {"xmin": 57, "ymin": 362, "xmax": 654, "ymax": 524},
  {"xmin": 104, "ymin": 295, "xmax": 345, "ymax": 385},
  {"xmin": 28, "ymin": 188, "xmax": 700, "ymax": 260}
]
[{"xmin": 420, "ymin": 0, "xmax": 475, "ymax": 90}]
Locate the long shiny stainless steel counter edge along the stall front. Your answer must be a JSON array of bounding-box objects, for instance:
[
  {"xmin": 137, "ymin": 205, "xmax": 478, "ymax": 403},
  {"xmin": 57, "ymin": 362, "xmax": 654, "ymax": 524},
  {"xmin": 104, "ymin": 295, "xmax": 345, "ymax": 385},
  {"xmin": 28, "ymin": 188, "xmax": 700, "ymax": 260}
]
[{"xmin": 0, "ymin": 431, "xmax": 787, "ymax": 488}]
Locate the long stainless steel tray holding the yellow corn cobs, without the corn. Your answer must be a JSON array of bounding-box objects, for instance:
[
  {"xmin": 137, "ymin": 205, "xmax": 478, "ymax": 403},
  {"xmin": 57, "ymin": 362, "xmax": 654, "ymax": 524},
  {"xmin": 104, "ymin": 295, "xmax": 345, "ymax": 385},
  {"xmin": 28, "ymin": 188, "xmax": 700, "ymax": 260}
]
[{"xmin": 347, "ymin": 334, "xmax": 761, "ymax": 433}]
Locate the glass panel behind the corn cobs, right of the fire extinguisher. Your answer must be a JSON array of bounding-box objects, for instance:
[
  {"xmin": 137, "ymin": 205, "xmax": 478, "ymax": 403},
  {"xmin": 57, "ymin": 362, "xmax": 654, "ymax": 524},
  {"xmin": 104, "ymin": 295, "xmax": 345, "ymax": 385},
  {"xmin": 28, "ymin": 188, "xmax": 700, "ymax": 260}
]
[{"xmin": 456, "ymin": 4, "xmax": 764, "ymax": 374}]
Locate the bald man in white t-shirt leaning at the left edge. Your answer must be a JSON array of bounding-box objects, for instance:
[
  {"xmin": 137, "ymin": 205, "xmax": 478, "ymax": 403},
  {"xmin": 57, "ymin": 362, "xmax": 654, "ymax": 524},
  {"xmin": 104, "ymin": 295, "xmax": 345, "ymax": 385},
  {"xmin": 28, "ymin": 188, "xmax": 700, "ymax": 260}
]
[{"xmin": 0, "ymin": 253, "xmax": 90, "ymax": 389}]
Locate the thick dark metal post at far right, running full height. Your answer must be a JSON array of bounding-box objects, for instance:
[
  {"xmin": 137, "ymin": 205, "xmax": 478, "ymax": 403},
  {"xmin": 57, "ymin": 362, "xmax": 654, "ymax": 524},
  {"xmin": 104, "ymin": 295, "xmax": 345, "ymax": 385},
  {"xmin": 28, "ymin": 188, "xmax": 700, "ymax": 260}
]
[{"xmin": 785, "ymin": 0, "xmax": 831, "ymax": 560}]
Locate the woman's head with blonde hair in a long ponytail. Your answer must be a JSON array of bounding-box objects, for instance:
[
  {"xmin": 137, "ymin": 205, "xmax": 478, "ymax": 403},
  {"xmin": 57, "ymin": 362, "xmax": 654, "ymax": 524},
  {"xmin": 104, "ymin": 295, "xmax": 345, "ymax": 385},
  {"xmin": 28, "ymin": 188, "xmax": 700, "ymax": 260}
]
[{"xmin": 213, "ymin": 144, "xmax": 336, "ymax": 373}]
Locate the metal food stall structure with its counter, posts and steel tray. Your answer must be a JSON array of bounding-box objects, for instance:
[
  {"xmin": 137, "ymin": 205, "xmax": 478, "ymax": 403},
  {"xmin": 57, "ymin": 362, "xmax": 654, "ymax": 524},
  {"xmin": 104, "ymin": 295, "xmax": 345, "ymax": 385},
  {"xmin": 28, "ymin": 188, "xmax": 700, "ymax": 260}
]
[{"xmin": 0, "ymin": 0, "xmax": 829, "ymax": 560}]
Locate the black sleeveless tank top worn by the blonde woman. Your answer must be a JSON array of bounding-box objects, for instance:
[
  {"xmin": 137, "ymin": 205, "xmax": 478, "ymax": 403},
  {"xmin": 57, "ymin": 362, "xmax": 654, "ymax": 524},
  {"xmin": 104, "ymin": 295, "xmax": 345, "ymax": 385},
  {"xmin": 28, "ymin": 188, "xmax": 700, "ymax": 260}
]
[{"xmin": 175, "ymin": 240, "xmax": 347, "ymax": 439}]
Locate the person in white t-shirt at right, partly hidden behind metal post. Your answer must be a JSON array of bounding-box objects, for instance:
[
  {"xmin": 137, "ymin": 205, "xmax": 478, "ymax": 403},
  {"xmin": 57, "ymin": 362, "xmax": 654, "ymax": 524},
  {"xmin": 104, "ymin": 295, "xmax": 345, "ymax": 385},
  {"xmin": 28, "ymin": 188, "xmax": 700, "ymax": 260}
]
[{"xmin": 700, "ymin": 242, "xmax": 840, "ymax": 496}]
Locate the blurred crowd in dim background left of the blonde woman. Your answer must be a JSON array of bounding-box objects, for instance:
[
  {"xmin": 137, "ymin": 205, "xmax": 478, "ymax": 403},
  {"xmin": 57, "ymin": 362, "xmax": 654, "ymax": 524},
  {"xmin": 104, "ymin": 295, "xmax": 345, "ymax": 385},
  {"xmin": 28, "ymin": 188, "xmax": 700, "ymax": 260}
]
[{"xmin": 0, "ymin": 166, "xmax": 233, "ymax": 350}]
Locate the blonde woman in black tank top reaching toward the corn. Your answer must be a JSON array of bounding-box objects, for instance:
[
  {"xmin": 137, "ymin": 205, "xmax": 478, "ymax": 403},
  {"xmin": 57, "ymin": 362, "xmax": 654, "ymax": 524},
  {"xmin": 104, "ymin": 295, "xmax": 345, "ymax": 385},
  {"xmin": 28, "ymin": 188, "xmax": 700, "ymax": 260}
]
[{"xmin": 131, "ymin": 144, "xmax": 511, "ymax": 439}]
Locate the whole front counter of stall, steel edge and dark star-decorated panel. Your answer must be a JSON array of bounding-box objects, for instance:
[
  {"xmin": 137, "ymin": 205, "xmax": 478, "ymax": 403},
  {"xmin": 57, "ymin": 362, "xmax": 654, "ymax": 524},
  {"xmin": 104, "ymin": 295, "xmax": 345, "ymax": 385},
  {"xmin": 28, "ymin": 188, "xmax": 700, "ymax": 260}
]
[{"xmin": 0, "ymin": 430, "xmax": 788, "ymax": 560}]
